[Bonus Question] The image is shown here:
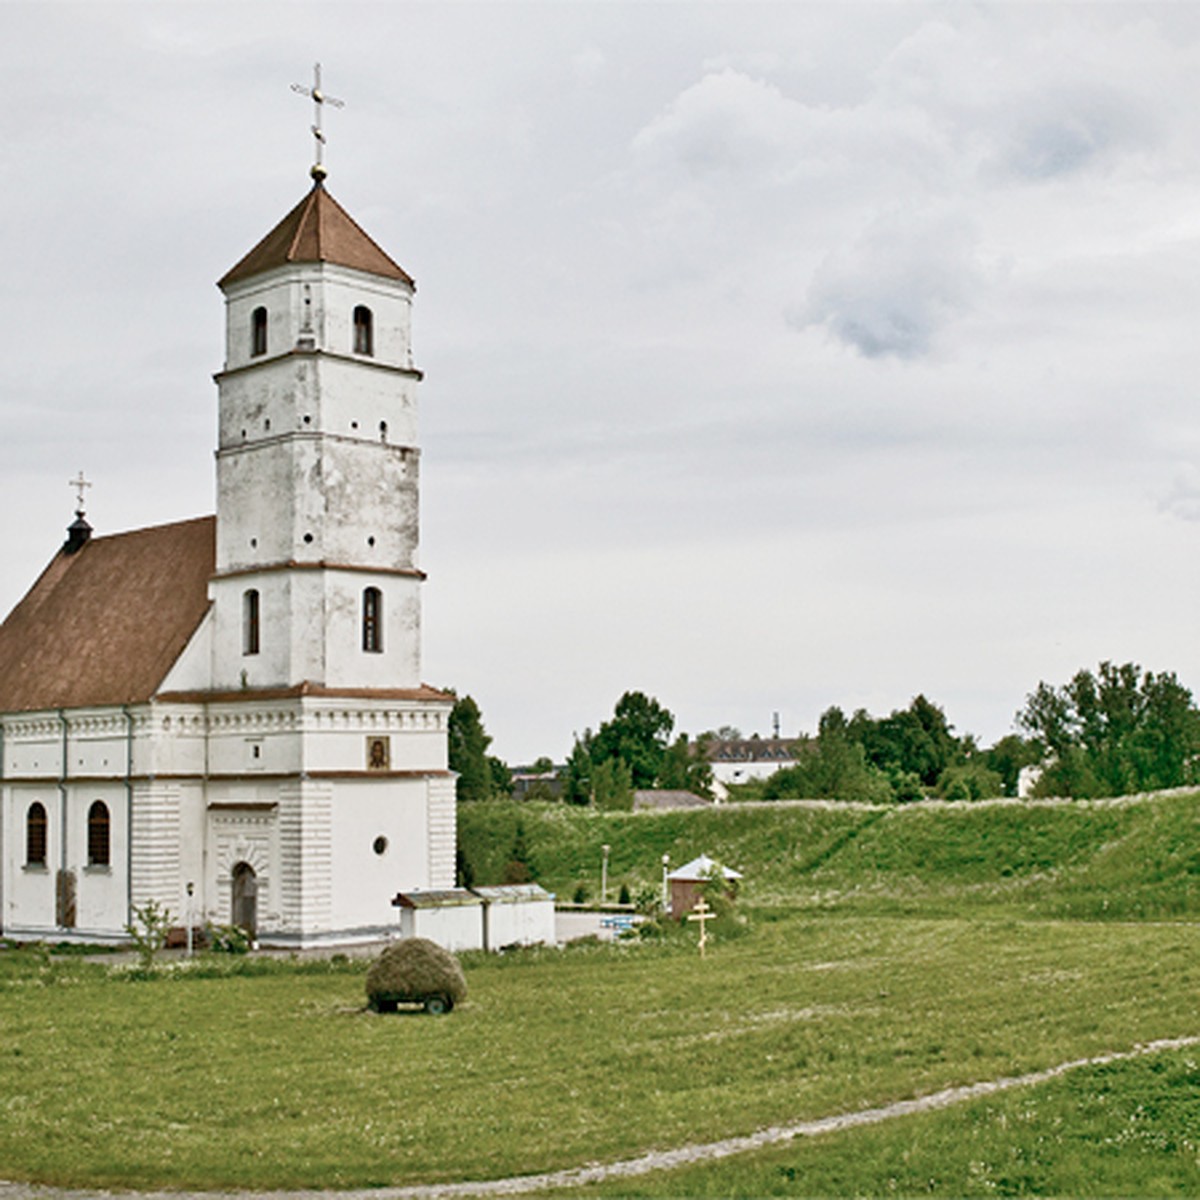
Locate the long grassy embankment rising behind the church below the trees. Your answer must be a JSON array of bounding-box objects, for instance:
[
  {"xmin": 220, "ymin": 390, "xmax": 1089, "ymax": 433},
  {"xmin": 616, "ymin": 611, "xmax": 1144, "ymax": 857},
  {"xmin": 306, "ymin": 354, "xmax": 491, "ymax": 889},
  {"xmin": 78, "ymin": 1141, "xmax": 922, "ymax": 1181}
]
[{"xmin": 458, "ymin": 793, "xmax": 1200, "ymax": 919}]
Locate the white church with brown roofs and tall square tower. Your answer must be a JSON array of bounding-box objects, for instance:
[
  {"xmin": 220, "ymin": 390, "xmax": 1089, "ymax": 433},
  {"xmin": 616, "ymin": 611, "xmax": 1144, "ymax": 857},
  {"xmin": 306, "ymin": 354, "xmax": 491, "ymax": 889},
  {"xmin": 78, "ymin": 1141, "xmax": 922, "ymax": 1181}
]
[{"xmin": 0, "ymin": 160, "xmax": 455, "ymax": 948}]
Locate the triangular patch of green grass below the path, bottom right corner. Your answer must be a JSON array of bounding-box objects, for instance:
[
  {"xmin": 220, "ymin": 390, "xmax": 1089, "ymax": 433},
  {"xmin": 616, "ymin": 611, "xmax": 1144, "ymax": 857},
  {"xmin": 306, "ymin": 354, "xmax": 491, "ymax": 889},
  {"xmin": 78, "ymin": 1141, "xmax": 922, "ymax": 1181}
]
[{"xmin": 544, "ymin": 1050, "xmax": 1200, "ymax": 1198}]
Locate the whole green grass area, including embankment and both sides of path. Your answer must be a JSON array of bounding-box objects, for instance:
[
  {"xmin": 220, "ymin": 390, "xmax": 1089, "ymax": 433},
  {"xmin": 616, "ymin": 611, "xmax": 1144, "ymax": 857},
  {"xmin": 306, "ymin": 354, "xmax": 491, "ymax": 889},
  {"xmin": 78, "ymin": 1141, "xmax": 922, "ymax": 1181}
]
[{"xmin": 0, "ymin": 798, "xmax": 1200, "ymax": 1195}]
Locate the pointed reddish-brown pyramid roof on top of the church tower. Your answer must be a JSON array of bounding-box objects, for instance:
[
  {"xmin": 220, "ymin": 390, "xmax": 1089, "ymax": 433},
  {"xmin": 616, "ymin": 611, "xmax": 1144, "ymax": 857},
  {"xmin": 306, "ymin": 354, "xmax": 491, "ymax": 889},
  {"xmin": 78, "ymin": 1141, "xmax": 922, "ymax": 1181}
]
[{"xmin": 217, "ymin": 182, "xmax": 413, "ymax": 288}]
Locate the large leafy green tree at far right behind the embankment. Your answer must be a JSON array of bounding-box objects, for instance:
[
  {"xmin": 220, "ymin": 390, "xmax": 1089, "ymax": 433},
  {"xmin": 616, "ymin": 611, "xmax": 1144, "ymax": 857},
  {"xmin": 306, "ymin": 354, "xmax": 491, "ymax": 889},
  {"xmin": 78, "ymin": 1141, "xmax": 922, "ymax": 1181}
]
[{"xmin": 1016, "ymin": 662, "xmax": 1200, "ymax": 798}]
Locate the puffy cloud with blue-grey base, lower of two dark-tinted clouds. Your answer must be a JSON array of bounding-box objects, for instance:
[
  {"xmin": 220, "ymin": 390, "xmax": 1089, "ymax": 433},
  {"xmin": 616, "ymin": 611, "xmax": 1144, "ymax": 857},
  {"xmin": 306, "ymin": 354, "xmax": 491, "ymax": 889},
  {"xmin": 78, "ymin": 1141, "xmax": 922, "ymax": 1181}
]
[{"xmin": 791, "ymin": 212, "xmax": 986, "ymax": 359}]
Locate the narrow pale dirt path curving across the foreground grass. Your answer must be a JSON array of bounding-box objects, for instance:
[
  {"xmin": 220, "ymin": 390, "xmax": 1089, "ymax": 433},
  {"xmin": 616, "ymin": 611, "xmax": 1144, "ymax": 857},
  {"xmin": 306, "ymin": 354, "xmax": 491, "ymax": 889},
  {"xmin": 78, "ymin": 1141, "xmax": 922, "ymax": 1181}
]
[{"xmin": 0, "ymin": 1037, "xmax": 1200, "ymax": 1200}]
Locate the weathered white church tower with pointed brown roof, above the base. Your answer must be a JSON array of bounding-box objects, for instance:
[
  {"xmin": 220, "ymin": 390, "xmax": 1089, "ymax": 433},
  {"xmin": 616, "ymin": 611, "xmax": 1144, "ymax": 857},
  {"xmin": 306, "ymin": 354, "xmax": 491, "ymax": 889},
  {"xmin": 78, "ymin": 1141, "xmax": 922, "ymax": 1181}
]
[{"xmin": 211, "ymin": 181, "xmax": 424, "ymax": 690}]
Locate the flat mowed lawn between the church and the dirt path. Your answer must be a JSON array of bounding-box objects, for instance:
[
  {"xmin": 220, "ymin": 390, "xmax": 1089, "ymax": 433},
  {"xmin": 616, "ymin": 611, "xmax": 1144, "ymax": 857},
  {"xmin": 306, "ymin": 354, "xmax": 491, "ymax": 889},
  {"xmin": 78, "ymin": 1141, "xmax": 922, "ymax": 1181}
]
[{"xmin": 0, "ymin": 911, "xmax": 1200, "ymax": 1194}]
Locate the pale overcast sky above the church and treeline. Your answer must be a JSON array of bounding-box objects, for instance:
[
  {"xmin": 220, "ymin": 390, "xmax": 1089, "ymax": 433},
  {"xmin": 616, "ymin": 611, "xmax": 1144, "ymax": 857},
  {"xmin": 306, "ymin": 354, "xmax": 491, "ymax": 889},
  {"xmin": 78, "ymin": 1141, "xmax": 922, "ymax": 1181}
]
[{"xmin": 0, "ymin": 0, "xmax": 1200, "ymax": 764}]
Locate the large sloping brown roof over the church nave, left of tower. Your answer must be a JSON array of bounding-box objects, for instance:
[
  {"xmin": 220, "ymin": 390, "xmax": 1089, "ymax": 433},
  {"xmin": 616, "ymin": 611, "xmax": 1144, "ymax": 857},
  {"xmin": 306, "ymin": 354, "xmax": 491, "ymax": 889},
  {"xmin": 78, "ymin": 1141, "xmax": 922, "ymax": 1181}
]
[{"xmin": 0, "ymin": 516, "xmax": 216, "ymax": 713}]
